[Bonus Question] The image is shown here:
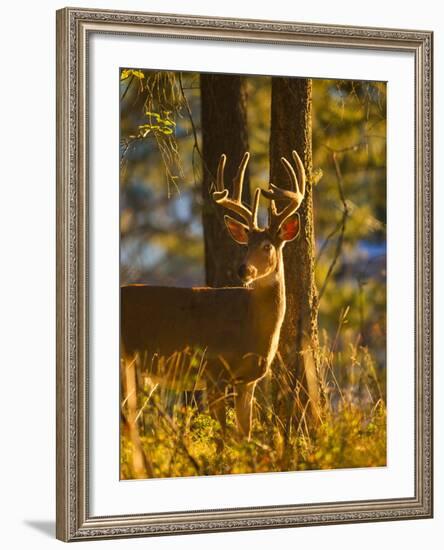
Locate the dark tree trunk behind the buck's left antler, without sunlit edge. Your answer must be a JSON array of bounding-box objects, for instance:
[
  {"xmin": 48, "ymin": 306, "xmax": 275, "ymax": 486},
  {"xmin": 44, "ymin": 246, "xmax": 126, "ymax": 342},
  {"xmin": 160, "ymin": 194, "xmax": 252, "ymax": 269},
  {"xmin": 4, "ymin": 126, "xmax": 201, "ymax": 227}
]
[{"xmin": 200, "ymin": 74, "xmax": 250, "ymax": 287}]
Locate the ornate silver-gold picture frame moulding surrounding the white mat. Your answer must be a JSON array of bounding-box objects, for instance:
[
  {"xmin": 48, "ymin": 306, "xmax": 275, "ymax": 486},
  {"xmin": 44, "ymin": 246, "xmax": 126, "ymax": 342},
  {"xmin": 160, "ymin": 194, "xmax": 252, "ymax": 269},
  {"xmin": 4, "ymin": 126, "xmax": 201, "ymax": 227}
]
[{"xmin": 56, "ymin": 8, "xmax": 433, "ymax": 541}]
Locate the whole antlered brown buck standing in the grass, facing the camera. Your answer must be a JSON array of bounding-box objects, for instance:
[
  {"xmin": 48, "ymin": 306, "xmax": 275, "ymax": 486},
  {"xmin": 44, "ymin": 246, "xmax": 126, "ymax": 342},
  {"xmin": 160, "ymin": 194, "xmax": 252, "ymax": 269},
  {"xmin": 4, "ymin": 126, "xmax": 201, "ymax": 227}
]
[{"xmin": 121, "ymin": 151, "xmax": 305, "ymax": 437}]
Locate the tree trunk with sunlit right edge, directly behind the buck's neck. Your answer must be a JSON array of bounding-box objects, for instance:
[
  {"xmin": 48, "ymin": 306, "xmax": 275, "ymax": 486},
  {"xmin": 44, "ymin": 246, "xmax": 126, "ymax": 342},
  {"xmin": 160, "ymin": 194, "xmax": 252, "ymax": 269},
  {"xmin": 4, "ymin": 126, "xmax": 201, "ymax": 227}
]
[{"xmin": 270, "ymin": 77, "xmax": 321, "ymax": 423}]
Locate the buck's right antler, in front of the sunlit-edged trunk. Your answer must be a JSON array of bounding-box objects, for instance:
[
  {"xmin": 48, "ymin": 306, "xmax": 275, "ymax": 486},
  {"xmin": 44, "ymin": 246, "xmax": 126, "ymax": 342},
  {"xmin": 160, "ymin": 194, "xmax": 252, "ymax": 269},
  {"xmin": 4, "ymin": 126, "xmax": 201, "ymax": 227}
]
[{"xmin": 262, "ymin": 151, "xmax": 306, "ymax": 231}]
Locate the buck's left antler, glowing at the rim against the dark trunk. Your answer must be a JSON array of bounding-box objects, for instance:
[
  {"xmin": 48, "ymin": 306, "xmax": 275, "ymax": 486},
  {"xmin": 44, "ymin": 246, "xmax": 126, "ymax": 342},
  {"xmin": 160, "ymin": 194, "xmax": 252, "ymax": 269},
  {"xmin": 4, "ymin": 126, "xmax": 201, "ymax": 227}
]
[{"xmin": 213, "ymin": 153, "xmax": 257, "ymax": 229}]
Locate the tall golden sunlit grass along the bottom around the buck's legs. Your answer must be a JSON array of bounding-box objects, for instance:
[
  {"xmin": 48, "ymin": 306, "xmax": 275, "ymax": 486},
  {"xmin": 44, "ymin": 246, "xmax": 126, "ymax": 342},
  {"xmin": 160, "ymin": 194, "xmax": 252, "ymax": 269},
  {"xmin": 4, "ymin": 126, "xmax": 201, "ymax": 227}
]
[{"xmin": 120, "ymin": 334, "xmax": 386, "ymax": 479}]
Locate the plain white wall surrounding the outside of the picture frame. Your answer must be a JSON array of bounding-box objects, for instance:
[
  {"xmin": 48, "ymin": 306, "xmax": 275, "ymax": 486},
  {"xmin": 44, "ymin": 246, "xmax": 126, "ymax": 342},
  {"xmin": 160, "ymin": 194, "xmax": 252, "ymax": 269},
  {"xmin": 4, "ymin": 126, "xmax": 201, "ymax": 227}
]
[{"xmin": 0, "ymin": 0, "xmax": 444, "ymax": 550}]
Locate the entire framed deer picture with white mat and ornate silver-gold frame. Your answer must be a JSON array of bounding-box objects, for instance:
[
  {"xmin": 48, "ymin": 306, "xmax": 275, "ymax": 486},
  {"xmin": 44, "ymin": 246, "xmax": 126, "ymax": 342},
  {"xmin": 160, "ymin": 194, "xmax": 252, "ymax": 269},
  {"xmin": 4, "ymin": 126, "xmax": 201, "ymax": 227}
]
[{"xmin": 56, "ymin": 8, "xmax": 433, "ymax": 541}]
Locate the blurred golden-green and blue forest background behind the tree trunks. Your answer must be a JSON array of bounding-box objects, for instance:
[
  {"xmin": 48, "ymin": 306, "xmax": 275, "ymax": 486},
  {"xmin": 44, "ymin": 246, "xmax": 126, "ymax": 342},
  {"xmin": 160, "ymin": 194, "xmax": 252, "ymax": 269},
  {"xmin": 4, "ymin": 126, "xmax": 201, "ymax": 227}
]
[{"xmin": 120, "ymin": 69, "xmax": 386, "ymax": 371}]
